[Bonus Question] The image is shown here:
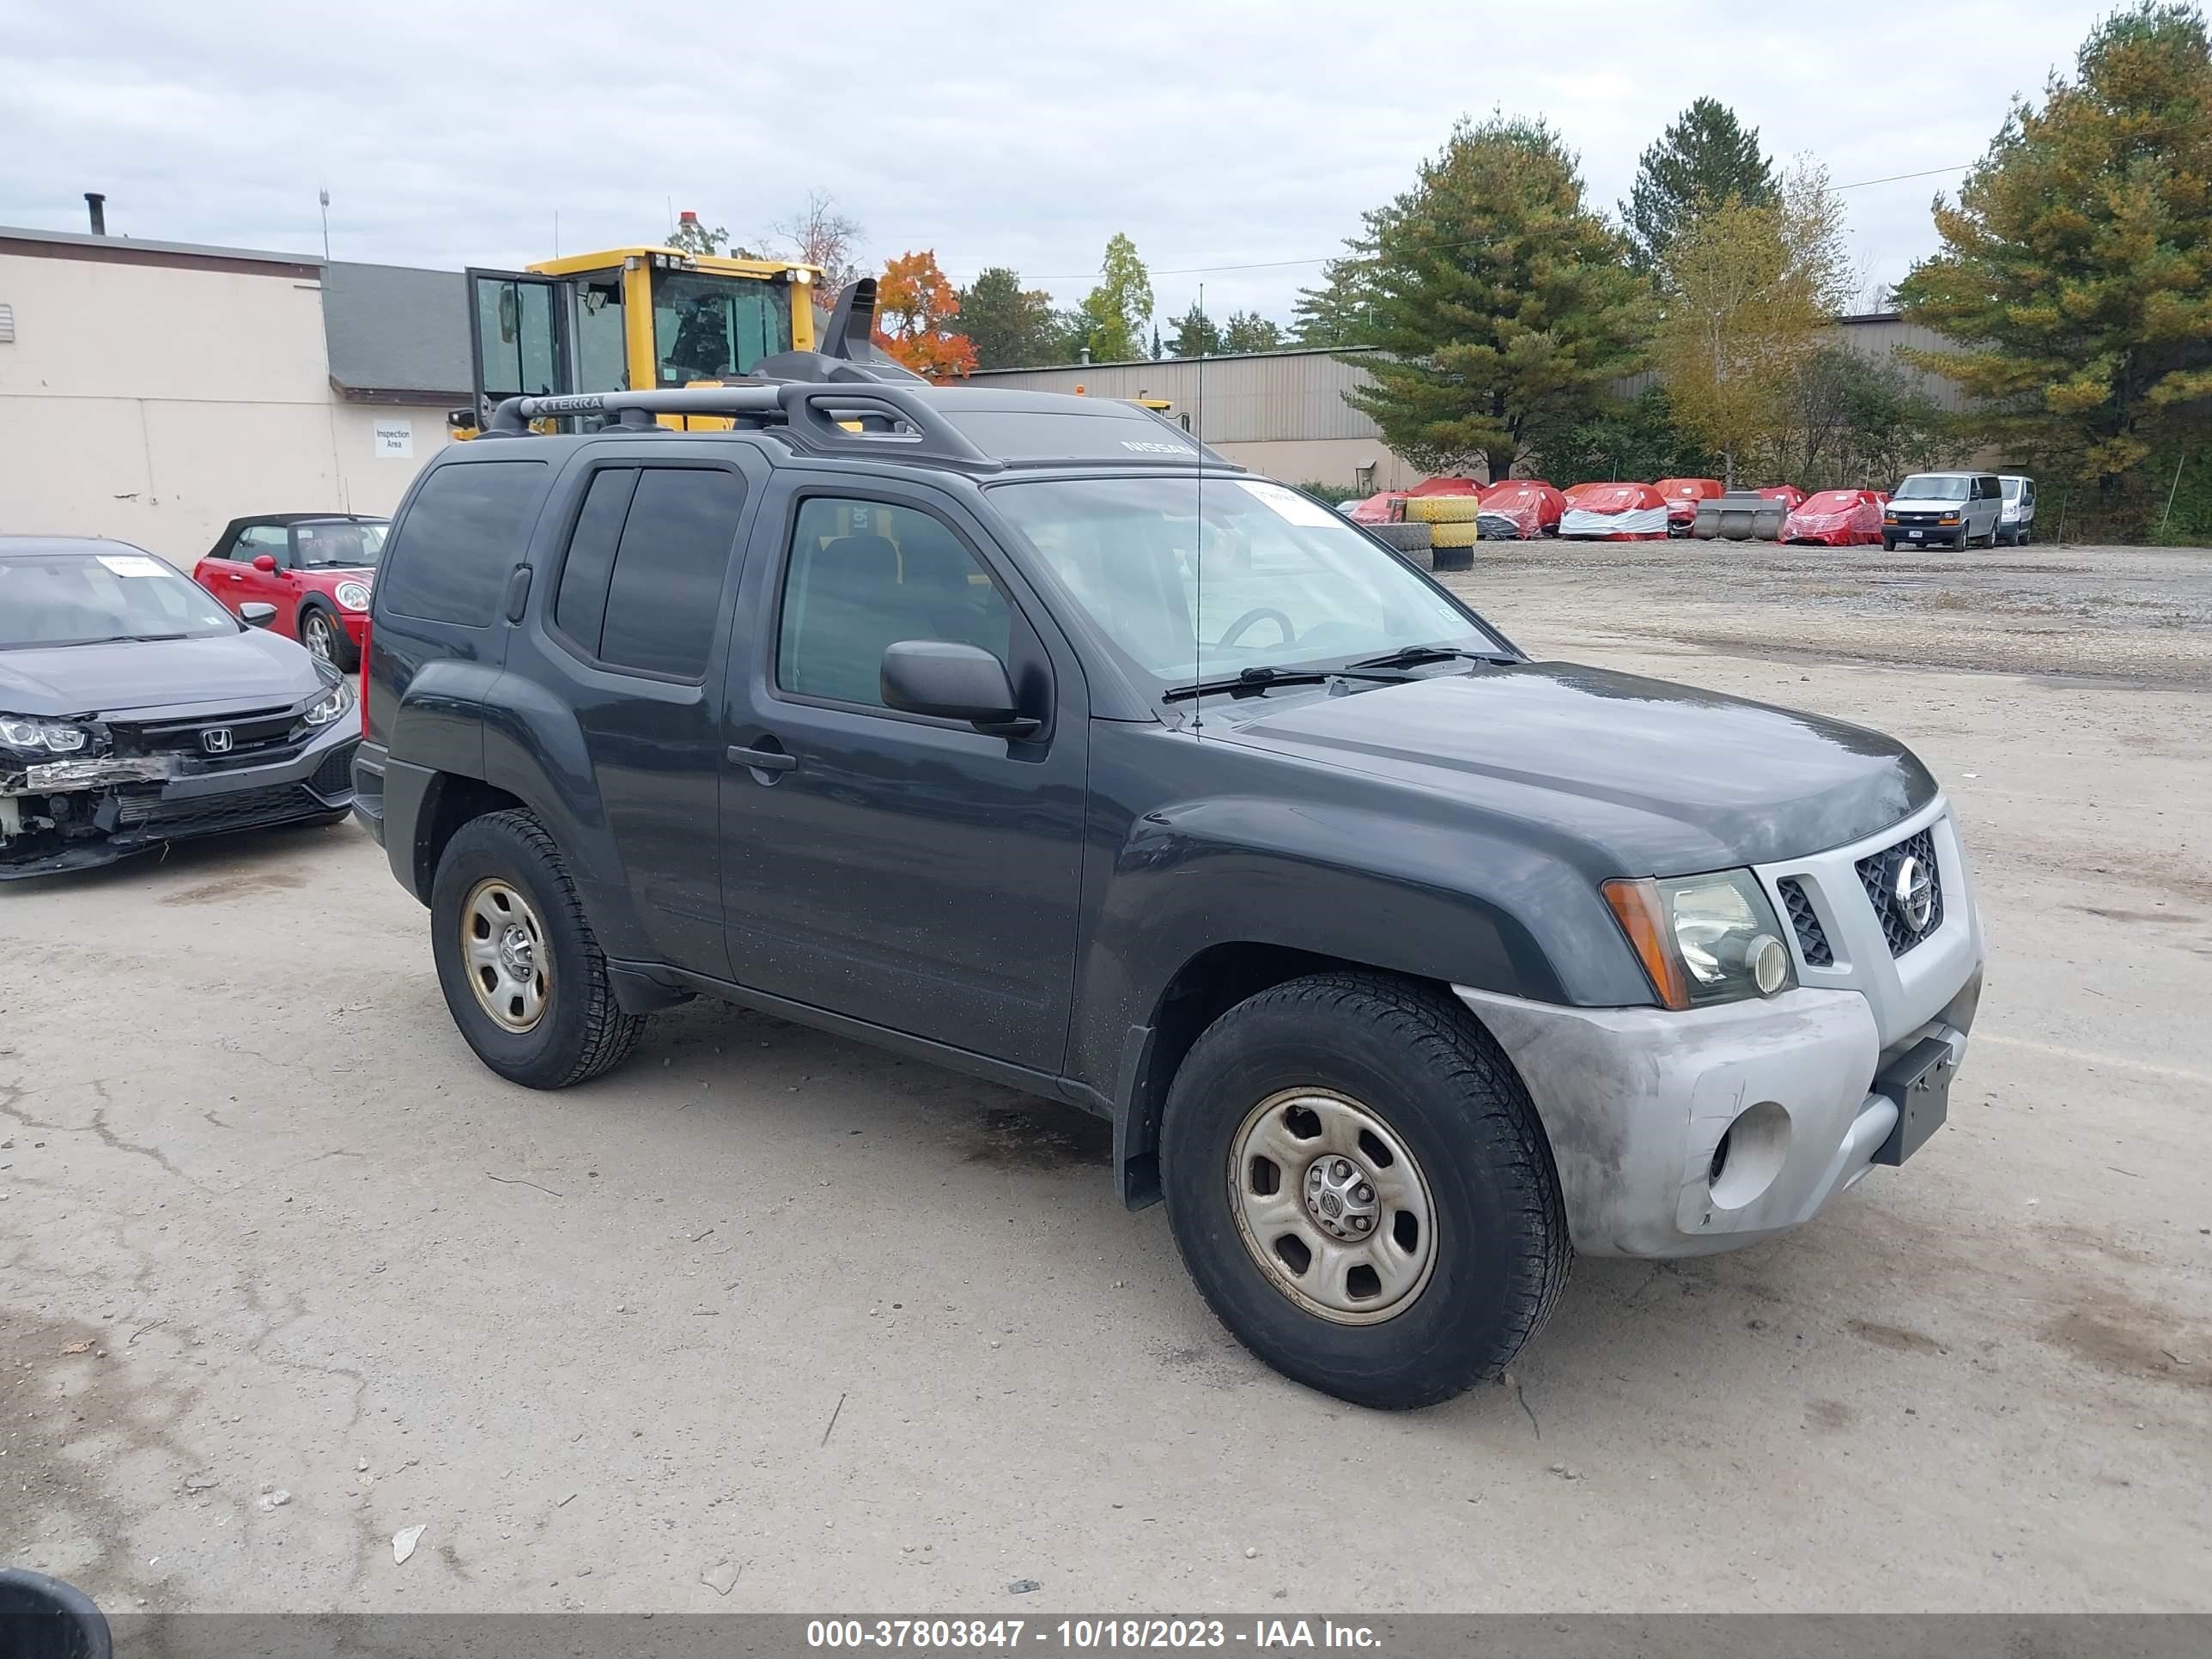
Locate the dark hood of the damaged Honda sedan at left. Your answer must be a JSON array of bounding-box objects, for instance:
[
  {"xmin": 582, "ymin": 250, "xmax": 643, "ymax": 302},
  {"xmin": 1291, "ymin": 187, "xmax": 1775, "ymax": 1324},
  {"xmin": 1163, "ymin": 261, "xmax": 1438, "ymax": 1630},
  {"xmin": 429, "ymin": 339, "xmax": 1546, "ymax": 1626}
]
[{"xmin": 0, "ymin": 629, "xmax": 323, "ymax": 719}]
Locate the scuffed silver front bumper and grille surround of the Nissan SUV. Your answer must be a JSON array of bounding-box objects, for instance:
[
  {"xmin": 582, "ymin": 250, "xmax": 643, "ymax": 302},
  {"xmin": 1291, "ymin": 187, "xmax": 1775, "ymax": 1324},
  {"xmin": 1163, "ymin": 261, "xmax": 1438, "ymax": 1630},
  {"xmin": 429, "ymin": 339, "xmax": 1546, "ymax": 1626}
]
[{"xmin": 1455, "ymin": 801, "xmax": 1982, "ymax": 1256}]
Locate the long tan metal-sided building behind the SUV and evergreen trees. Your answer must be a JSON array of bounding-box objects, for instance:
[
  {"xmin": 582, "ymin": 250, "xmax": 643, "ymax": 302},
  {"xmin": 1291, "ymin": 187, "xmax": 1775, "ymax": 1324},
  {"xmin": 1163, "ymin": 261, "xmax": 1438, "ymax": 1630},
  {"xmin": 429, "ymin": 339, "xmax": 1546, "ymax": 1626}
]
[{"xmin": 971, "ymin": 312, "xmax": 1960, "ymax": 489}]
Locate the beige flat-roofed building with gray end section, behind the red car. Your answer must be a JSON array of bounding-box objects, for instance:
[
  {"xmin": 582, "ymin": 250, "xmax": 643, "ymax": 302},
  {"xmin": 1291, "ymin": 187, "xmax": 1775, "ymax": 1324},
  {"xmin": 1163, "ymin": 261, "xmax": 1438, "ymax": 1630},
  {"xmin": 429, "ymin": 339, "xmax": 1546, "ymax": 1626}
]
[{"xmin": 0, "ymin": 226, "xmax": 469, "ymax": 568}]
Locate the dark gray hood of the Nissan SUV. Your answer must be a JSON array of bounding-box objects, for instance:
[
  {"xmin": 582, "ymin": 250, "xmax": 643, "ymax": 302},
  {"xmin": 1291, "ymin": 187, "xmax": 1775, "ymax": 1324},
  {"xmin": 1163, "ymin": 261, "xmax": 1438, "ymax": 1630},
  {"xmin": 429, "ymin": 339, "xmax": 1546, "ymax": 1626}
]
[{"xmin": 1207, "ymin": 661, "xmax": 1936, "ymax": 876}]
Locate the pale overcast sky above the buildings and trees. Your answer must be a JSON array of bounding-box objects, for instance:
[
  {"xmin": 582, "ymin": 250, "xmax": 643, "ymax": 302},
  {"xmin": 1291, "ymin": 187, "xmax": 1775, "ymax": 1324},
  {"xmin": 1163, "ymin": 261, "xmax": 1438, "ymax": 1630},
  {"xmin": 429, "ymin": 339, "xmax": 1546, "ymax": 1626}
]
[{"xmin": 0, "ymin": 0, "xmax": 2104, "ymax": 321}]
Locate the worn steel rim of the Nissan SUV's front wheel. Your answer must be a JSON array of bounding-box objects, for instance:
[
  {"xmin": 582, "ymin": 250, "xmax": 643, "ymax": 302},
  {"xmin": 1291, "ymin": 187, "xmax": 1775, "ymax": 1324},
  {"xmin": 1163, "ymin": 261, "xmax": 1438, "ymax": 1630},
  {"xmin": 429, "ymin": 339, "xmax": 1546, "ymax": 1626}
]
[{"xmin": 1228, "ymin": 1088, "xmax": 1436, "ymax": 1325}]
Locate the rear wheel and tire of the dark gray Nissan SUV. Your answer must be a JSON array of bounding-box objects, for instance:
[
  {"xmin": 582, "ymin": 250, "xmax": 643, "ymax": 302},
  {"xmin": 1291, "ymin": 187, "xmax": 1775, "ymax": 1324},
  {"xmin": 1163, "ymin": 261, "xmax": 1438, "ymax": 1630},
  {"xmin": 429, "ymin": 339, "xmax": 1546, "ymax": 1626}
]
[{"xmin": 429, "ymin": 811, "xmax": 646, "ymax": 1088}]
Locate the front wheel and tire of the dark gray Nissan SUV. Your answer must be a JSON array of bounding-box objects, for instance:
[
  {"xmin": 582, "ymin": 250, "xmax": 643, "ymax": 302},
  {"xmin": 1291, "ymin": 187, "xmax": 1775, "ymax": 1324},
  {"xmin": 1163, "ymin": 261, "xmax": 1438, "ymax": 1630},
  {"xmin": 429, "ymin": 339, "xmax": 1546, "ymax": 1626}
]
[{"xmin": 1161, "ymin": 971, "xmax": 1573, "ymax": 1411}]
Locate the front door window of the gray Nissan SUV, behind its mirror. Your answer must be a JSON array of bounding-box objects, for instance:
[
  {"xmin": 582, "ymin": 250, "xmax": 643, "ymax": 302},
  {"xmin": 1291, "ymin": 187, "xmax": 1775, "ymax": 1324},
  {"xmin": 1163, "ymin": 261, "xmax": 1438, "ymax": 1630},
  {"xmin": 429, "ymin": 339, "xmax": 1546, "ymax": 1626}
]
[{"xmin": 776, "ymin": 495, "xmax": 1013, "ymax": 708}]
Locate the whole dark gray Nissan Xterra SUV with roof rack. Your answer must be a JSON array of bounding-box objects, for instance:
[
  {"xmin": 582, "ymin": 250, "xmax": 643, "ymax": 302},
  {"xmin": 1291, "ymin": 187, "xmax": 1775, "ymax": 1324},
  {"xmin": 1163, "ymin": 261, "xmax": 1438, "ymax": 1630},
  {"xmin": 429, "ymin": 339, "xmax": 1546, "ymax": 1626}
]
[{"xmin": 356, "ymin": 331, "xmax": 1982, "ymax": 1407}]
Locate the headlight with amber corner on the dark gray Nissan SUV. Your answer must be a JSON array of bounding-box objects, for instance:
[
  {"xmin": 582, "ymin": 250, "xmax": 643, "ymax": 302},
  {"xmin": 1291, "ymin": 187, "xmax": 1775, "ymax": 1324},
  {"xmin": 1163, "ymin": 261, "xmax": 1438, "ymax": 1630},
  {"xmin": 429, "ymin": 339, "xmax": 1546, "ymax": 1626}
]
[{"xmin": 1606, "ymin": 869, "xmax": 1796, "ymax": 1009}]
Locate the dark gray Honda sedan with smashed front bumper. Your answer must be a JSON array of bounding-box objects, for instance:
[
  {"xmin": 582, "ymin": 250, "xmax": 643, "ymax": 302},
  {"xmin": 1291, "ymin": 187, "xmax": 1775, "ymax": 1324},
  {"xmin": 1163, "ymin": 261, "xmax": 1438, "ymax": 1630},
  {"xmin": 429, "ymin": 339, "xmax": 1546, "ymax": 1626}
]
[{"xmin": 0, "ymin": 535, "xmax": 361, "ymax": 880}]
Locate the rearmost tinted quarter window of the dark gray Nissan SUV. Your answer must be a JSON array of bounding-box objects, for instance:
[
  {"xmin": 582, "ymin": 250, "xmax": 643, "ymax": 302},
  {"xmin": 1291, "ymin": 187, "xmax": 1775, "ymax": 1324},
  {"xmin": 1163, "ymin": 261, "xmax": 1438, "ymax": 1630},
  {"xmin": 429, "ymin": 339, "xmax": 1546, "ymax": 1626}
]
[{"xmin": 376, "ymin": 460, "xmax": 546, "ymax": 629}]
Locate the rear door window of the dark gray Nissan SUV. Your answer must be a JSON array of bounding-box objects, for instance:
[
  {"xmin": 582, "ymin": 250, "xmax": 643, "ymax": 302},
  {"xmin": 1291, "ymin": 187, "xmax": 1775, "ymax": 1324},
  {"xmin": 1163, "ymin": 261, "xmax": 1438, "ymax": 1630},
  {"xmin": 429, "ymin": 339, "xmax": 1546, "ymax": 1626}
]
[{"xmin": 553, "ymin": 467, "xmax": 745, "ymax": 679}]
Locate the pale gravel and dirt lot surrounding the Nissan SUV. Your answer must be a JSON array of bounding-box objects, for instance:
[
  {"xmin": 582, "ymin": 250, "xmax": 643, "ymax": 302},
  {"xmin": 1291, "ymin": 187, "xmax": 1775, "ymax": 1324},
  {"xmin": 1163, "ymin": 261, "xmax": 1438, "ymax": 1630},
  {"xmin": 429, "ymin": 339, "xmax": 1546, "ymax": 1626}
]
[{"xmin": 0, "ymin": 544, "xmax": 2212, "ymax": 1613}]
